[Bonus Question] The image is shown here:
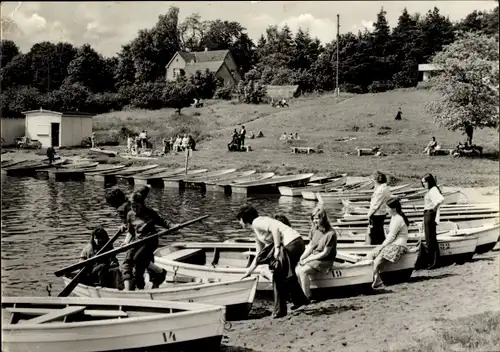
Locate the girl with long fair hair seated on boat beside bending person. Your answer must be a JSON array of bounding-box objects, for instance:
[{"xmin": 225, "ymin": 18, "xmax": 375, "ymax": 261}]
[{"xmin": 295, "ymin": 206, "xmax": 337, "ymax": 299}]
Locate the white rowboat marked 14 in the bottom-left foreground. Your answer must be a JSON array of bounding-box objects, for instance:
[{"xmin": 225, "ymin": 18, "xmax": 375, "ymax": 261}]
[{"xmin": 2, "ymin": 297, "xmax": 224, "ymax": 352}]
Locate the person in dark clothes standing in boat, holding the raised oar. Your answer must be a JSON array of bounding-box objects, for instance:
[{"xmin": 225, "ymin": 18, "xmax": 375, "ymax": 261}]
[{"xmin": 123, "ymin": 192, "xmax": 175, "ymax": 291}]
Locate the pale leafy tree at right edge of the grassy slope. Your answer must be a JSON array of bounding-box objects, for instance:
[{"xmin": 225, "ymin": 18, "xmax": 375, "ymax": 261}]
[{"xmin": 426, "ymin": 33, "xmax": 499, "ymax": 143}]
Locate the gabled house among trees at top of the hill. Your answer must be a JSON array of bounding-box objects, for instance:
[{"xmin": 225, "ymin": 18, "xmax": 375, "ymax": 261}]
[{"xmin": 165, "ymin": 49, "xmax": 241, "ymax": 84}]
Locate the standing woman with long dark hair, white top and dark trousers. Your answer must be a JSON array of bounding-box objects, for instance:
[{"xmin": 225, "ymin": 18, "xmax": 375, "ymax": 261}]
[{"xmin": 422, "ymin": 174, "xmax": 444, "ymax": 269}]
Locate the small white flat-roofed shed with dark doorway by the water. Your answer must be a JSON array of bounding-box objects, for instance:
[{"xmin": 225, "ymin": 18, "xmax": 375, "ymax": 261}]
[{"xmin": 23, "ymin": 109, "xmax": 94, "ymax": 148}]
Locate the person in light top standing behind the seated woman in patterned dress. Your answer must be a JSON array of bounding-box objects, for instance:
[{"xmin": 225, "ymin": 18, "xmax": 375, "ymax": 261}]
[{"xmin": 366, "ymin": 171, "xmax": 391, "ymax": 245}]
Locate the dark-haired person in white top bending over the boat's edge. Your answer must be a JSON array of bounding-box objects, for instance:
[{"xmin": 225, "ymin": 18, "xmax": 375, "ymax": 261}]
[{"xmin": 236, "ymin": 205, "xmax": 309, "ymax": 318}]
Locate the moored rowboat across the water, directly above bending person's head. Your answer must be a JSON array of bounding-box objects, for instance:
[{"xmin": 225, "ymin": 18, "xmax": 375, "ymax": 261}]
[{"xmin": 230, "ymin": 173, "xmax": 314, "ymax": 195}]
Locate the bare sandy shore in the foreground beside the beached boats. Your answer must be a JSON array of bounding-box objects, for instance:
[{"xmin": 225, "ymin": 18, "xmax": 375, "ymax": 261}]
[{"xmin": 224, "ymin": 252, "xmax": 500, "ymax": 352}]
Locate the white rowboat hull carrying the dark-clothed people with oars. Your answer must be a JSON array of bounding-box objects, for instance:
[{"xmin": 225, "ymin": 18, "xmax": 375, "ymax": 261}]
[{"xmin": 64, "ymin": 277, "xmax": 257, "ymax": 320}]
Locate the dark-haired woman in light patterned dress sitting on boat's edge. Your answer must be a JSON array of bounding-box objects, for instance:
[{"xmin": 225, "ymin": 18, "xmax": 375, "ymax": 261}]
[{"xmin": 371, "ymin": 198, "xmax": 410, "ymax": 289}]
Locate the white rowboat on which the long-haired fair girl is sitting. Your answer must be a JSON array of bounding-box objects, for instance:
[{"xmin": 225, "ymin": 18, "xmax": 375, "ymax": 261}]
[{"xmin": 155, "ymin": 242, "xmax": 396, "ymax": 293}]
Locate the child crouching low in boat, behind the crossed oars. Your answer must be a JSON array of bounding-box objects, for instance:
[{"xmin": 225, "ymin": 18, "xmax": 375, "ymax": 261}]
[{"xmin": 80, "ymin": 226, "xmax": 123, "ymax": 290}]
